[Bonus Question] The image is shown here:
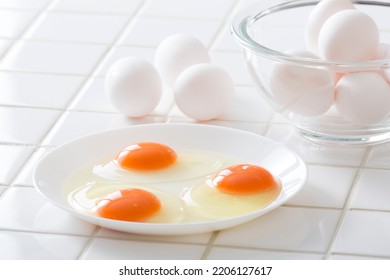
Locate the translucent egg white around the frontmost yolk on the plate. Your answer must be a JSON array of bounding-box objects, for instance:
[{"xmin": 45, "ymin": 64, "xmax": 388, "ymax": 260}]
[{"xmin": 68, "ymin": 182, "xmax": 185, "ymax": 223}]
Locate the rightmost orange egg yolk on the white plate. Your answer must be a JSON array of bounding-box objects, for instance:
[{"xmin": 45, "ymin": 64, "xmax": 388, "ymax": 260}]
[{"xmin": 211, "ymin": 164, "xmax": 278, "ymax": 195}]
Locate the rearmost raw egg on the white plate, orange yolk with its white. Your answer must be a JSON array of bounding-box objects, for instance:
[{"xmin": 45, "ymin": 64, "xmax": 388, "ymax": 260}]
[{"xmin": 93, "ymin": 142, "xmax": 236, "ymax": 183}]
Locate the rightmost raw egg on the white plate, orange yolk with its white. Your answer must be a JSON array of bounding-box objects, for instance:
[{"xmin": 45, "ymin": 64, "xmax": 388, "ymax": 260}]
[{"xmin": 183, "ymin": 164, "xmax": 281, "ymax": 220}]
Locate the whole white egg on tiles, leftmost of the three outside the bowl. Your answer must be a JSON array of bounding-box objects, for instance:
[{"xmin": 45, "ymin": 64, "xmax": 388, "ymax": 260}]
[{"xmin": 105, "ymin": 57, "xmax": 162, "ymax": 117}]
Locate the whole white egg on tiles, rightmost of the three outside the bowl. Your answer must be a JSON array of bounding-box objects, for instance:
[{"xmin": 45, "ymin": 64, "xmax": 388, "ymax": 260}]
[{"xmin": 174, "ymin": 63, "xmax": 234, "ymax": 121}]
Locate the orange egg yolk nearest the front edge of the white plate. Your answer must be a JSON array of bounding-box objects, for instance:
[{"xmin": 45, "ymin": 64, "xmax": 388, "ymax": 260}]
[{"xmin": 96, "ymin": 189, "xmax": 161, "ymax": 222}]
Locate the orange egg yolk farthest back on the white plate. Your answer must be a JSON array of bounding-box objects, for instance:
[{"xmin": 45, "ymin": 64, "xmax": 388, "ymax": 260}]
[{"xmin": 116, "ymin": 142, "xmax": 177, "ymax": 171}]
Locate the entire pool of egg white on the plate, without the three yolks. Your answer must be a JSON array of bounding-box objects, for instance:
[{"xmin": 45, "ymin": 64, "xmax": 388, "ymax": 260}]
[{"xmin": 63, "ymin": 150, "xmax": 281, "ymax": 223}]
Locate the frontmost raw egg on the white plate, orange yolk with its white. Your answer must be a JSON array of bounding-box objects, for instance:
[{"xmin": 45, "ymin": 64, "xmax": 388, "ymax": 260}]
[{"xmin": 68, "ymin": 182, "xmax": 184, "ymax": 223}]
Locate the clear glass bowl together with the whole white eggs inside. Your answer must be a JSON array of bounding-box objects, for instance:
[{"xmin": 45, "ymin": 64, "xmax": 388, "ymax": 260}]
[{"xmin": 231, "ymin": 0, "xmax": 390, "ymax": 145}]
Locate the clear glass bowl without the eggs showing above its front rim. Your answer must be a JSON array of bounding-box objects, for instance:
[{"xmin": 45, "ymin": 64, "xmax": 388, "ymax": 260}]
[{"xmin": 232, "ymin": 0, "xmax": 390, "ymax": 145}]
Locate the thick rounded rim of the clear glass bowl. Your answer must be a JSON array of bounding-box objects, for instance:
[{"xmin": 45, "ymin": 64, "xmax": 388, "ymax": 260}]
[{"xmin": 231, "ymin": 0, "xmax": 390, "ymax": 71}]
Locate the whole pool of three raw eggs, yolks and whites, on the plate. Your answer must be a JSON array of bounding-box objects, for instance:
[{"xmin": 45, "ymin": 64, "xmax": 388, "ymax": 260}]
[{"xmin": 66, "ymin": 142, "xmax": 281, "ymax": 223}]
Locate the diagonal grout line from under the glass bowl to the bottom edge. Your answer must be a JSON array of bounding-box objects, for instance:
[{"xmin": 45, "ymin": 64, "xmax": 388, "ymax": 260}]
[{"xmin": 325, "ymin": 147, "xmax": 372, "ymax": 259}]
